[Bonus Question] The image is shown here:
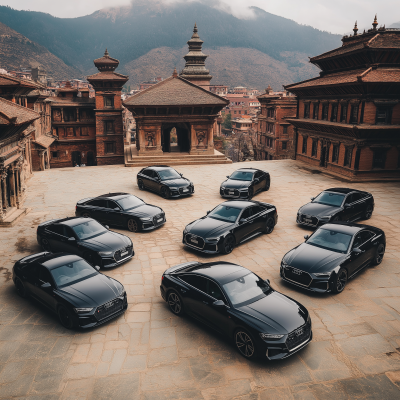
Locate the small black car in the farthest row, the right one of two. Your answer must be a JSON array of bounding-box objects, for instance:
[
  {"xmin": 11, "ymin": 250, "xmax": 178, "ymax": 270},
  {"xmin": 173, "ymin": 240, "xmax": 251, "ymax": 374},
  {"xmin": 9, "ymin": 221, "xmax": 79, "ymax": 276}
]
[{"xmin": 219, "ymin": 168, "xmax": 271, "ymax": 199}]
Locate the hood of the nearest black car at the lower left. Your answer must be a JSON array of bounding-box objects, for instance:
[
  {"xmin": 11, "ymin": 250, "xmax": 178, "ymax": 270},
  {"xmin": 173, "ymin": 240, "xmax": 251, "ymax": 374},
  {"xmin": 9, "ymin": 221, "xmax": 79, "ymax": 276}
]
[{"xmin": 58, "ymin": 274, "xmax": 124, "ymax": 307}]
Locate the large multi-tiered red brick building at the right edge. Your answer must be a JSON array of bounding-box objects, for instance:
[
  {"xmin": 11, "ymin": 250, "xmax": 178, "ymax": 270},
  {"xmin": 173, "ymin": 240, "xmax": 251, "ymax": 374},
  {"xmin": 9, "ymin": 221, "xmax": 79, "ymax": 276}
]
[{"xmin": 285, "ymin": 17, "xmax": 400, "ymax": 181}]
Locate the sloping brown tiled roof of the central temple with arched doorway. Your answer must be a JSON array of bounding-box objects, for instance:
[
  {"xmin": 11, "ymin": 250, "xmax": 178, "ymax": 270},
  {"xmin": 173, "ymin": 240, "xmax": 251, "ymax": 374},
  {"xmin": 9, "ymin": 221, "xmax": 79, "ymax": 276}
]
[{"xmin": 123, "ymin": 76, "xmax": 229, "ymax": 106}]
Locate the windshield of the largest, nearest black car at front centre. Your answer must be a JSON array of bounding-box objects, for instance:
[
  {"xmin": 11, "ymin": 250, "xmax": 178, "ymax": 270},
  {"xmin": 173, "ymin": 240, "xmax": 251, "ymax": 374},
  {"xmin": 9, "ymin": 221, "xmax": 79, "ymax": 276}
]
[{"xmin": 222, "ymin": 272, "xmax": 271, "ymax": 307}]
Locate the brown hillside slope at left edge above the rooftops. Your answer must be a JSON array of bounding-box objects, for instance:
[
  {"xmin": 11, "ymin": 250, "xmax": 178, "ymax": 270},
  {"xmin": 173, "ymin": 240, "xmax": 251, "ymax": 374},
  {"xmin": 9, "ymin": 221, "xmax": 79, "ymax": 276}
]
[{"xmin": 0, "ymin": 22, "xmax": 82, "ymax": 79}]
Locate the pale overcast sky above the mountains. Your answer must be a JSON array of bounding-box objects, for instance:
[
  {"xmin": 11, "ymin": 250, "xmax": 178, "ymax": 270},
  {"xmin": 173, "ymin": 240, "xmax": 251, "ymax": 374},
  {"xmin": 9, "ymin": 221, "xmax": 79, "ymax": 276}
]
[{"xmin": 0, "ymin": 0, "xmax": 400, "ymax": 34}]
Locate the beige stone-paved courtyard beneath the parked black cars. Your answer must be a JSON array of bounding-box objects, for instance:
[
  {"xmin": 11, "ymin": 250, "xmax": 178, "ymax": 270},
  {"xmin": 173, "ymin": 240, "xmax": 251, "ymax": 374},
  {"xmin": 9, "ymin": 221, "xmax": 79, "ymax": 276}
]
[{"xmin": 0, "ymin": 160, "xmax": 400, "ymax": 400}]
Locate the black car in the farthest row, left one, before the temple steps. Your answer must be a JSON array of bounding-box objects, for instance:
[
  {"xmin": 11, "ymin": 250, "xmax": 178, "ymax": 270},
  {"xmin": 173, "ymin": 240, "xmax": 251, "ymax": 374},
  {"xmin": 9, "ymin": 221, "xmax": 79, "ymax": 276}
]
[{"xmin": 137, "ymin": 165, "xmax": 194, "ymax": 199}]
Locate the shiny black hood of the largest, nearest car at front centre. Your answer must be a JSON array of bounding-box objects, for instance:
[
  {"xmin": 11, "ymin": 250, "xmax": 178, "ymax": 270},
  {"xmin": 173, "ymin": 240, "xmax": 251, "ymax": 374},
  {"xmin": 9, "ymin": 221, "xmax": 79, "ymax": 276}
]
[{"xmin": 238, "ymin": 291, "xmax": 308, "ymax": 334}]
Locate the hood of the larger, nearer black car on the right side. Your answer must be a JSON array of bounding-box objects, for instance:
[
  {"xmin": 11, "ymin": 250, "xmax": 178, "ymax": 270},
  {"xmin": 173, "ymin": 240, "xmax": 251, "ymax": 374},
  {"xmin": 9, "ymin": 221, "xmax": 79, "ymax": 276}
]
[{"xmin": 283, "ymin": 243, "xmax": 347, "ymax": 273}]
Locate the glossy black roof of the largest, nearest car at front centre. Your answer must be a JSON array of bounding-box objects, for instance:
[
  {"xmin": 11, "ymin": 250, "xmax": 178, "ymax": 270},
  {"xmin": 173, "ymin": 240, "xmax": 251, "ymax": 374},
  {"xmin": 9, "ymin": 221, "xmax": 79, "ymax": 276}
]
[{"xmin": 182, "ymin": 261, "xmax": 251, "ymax": 285}]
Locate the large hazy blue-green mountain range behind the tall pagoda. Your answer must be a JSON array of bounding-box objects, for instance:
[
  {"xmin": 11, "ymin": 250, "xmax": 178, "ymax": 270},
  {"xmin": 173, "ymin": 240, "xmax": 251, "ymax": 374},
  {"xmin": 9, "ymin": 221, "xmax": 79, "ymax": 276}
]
[{"xmin": 0, "ymin": 0, "xmax": 341, "ymax": 86}]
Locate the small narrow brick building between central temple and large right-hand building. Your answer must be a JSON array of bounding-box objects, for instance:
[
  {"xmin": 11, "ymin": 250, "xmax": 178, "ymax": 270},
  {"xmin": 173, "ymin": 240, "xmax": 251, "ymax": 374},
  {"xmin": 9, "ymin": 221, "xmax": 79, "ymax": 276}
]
[{"xmin": 257, "ymin": 86, "xmax": 297, "ymax": 160}]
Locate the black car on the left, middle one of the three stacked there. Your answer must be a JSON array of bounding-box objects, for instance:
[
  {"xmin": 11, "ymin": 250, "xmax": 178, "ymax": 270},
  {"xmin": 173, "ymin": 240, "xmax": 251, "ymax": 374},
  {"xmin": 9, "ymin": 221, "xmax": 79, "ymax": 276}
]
[{"xmin": 37, "ymin": 217, "xmax": 135, "ymax": 268}]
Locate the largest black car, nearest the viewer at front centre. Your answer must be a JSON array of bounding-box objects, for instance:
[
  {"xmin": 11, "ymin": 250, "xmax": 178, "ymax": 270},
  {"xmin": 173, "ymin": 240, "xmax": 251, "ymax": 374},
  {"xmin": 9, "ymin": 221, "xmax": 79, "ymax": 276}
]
[{"xmin": 160, "ymin": 261, "xmax": 312, "ymax": 360}]
